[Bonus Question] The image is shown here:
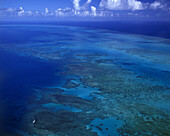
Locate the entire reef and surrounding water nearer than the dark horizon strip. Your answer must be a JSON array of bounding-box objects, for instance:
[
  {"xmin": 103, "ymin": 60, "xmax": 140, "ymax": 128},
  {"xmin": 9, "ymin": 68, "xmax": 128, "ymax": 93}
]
[{"xmin": 0, "ymin": 25, "xmax": 170, "ymax": 136}]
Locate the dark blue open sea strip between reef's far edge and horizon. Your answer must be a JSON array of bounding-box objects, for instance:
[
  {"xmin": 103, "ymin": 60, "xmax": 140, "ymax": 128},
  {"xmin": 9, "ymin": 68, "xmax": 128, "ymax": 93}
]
[{"xmin": 0, "ymin": 20, "xmax": 170, "ymax": 39}]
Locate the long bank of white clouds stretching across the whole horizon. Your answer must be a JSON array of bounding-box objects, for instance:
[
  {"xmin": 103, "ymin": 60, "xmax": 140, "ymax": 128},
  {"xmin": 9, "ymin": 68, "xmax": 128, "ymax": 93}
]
[{"xmin": 0, "ymin": 0, "xmax": 170, "ymax": 19}]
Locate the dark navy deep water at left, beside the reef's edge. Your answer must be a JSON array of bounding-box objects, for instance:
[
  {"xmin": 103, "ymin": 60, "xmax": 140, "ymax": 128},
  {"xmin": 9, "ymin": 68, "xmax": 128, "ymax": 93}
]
[{"xmin": 0, "ymin": 50, "xmax": 61, "ymax": 133}]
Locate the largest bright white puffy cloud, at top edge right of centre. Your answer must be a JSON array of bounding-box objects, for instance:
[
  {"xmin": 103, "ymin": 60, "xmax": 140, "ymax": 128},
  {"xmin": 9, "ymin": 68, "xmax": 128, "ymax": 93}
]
[{"xmin": 99, "ymin": 0, "xmax": 144, "ymax": 10}]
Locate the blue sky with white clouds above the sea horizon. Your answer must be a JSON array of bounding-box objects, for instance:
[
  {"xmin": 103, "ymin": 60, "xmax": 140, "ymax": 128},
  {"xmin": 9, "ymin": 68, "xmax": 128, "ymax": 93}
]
[{"xmin": 0, "ymin": 0, "xmax": 170, "ymax": 20}]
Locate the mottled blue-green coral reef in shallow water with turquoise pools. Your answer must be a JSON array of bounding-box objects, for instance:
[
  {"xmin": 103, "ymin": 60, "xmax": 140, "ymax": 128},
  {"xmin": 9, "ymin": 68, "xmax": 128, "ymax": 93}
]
[{"xmin": 0, "ymin": 26, "xmax": 170, "ymax": 136}]
